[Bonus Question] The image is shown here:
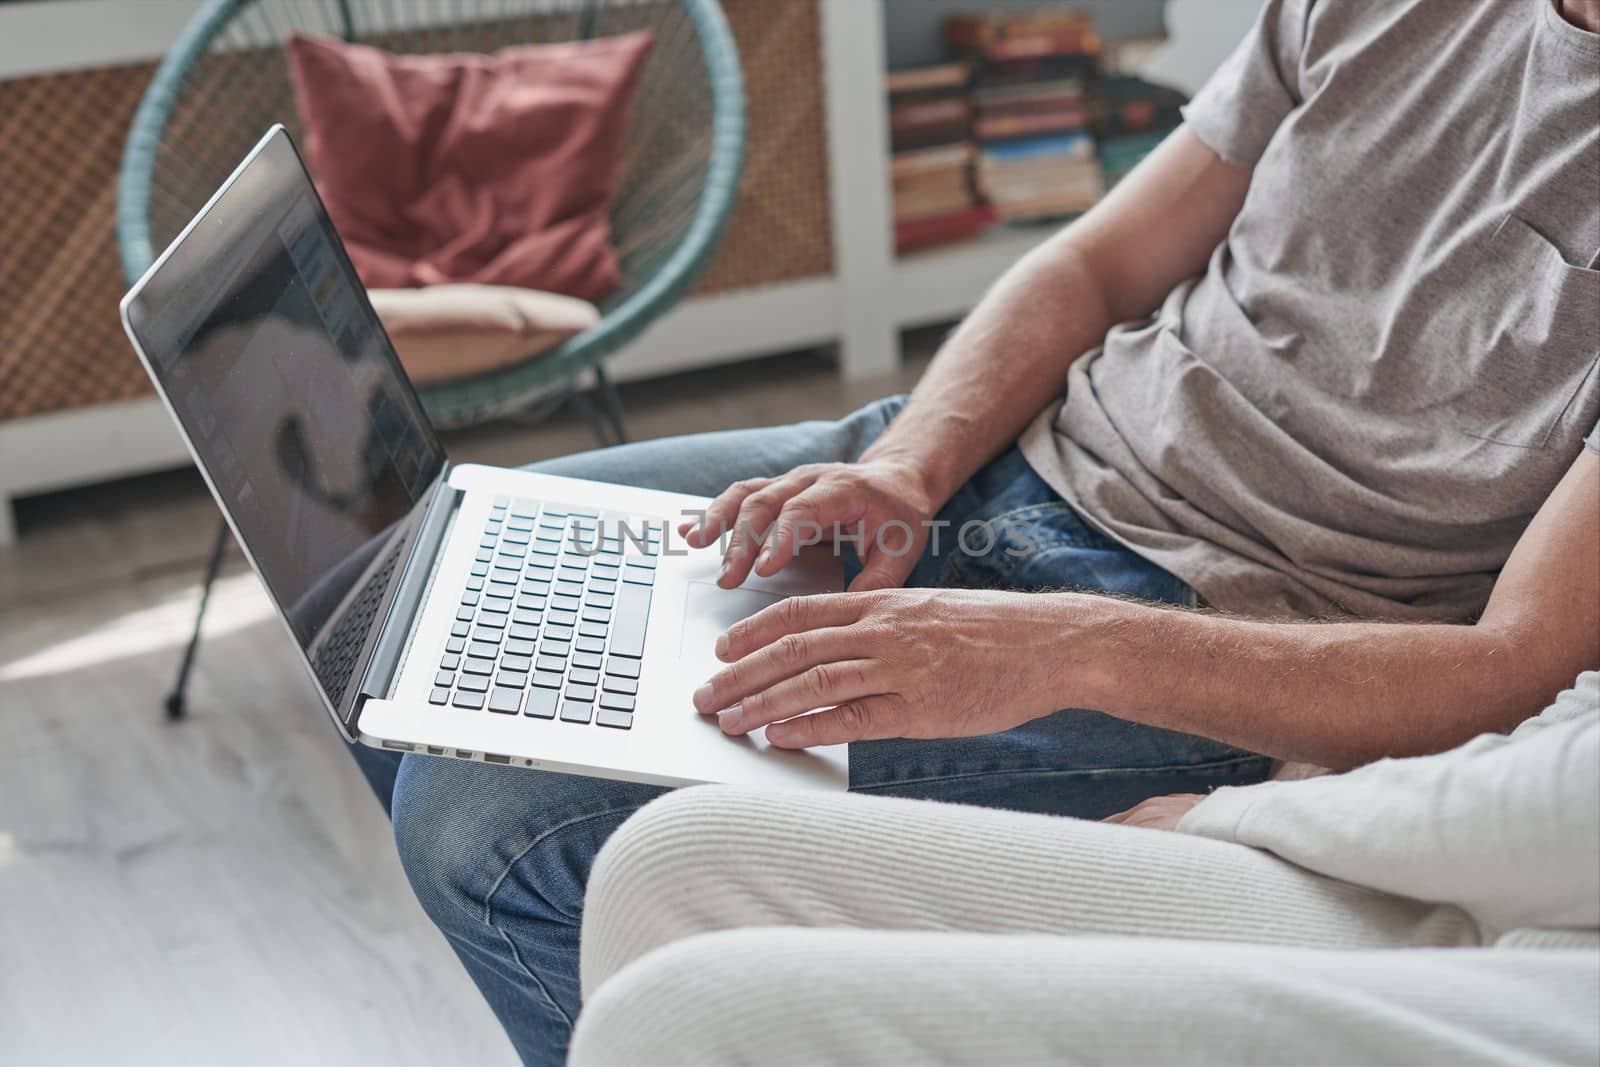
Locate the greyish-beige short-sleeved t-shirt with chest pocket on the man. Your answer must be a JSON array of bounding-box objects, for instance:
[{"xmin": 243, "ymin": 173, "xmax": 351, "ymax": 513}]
[{"xmin": 1021, "ymin": 0, "xmax": 1600, "ymax": 621}]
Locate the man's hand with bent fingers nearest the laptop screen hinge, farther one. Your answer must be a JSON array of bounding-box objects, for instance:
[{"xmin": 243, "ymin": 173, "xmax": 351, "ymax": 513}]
[{"xmin": 678, "ymin": 459, "xmax": 942, "ymax": 592}]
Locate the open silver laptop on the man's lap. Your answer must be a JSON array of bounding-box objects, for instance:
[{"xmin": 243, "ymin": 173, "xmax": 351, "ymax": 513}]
[{"xmin": 122, "ymin": 126, "xmax": 848, "ymax": 790}]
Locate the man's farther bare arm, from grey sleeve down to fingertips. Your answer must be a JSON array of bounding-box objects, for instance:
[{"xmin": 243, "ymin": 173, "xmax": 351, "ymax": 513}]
[{"xmin": 680, "ymin": 128, "xmax": 1250, "ymax": 590}]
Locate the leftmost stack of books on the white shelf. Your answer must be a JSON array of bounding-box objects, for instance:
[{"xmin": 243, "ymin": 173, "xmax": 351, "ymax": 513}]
[{"xmin": 888, "ymin": 62, "xmax": 994, "ymax": 253}]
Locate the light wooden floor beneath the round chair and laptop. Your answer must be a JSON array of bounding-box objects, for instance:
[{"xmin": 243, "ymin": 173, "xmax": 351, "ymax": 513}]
[{"xmin": 0, "ymin": 347, "xmax": 931, "ymax": 1064}]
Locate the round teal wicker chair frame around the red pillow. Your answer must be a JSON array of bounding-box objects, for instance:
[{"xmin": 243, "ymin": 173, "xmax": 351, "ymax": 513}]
[{"xmin": 117, "ymin": 0, "xmax": 744, "ymax": 438}]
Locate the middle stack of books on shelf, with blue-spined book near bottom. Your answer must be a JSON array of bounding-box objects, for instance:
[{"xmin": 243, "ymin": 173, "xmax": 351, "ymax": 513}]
[{"xmin": 944, "ymin": 11, "xmax": 1104, "ymax": 221}]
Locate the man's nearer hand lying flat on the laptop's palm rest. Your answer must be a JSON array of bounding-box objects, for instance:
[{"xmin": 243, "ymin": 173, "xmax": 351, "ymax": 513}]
[{"xmin": 694, "ymin": 589, "xmax": 1075, "ymax": 749}]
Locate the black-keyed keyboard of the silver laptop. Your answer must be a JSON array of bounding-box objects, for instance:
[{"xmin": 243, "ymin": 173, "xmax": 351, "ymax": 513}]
[{"xmin": 427, "ymin": 496, "xmax": 666, "ymax": 729}]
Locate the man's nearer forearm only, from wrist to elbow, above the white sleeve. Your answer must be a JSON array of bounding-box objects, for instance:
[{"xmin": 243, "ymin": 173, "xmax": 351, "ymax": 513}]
[{"xmin": 1059, "ymin": 593, "xmax": 1592, "ymax": 768}]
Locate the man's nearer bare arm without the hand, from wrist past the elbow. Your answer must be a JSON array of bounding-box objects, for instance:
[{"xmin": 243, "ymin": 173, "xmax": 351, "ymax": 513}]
[{"xmin": 1075, "ymin": 451, "xmax": 1600, "ymax": 768}]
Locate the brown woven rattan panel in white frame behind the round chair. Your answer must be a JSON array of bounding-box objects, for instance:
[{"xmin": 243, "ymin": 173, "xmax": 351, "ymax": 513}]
[{"xmin": 0, "ymin": 0, "xmax": 834, "ymax": 419}]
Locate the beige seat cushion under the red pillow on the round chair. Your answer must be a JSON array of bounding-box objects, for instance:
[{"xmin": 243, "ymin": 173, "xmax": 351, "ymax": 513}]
[{"xmin": 368, "ymin": 285, "xmax": 600, "ymax": 386}]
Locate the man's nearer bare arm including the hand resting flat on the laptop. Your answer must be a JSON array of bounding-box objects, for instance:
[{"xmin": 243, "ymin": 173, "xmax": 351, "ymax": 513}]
[{"xmin": 694, "ymin": 453, "xmax": 1600, "ymax": 768}]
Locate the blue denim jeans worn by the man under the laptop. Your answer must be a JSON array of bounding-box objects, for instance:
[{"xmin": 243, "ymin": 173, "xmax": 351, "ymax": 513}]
[{"xmin": 357, "ymin": 398, "xmax": 1269, "ymax": 1064}]
